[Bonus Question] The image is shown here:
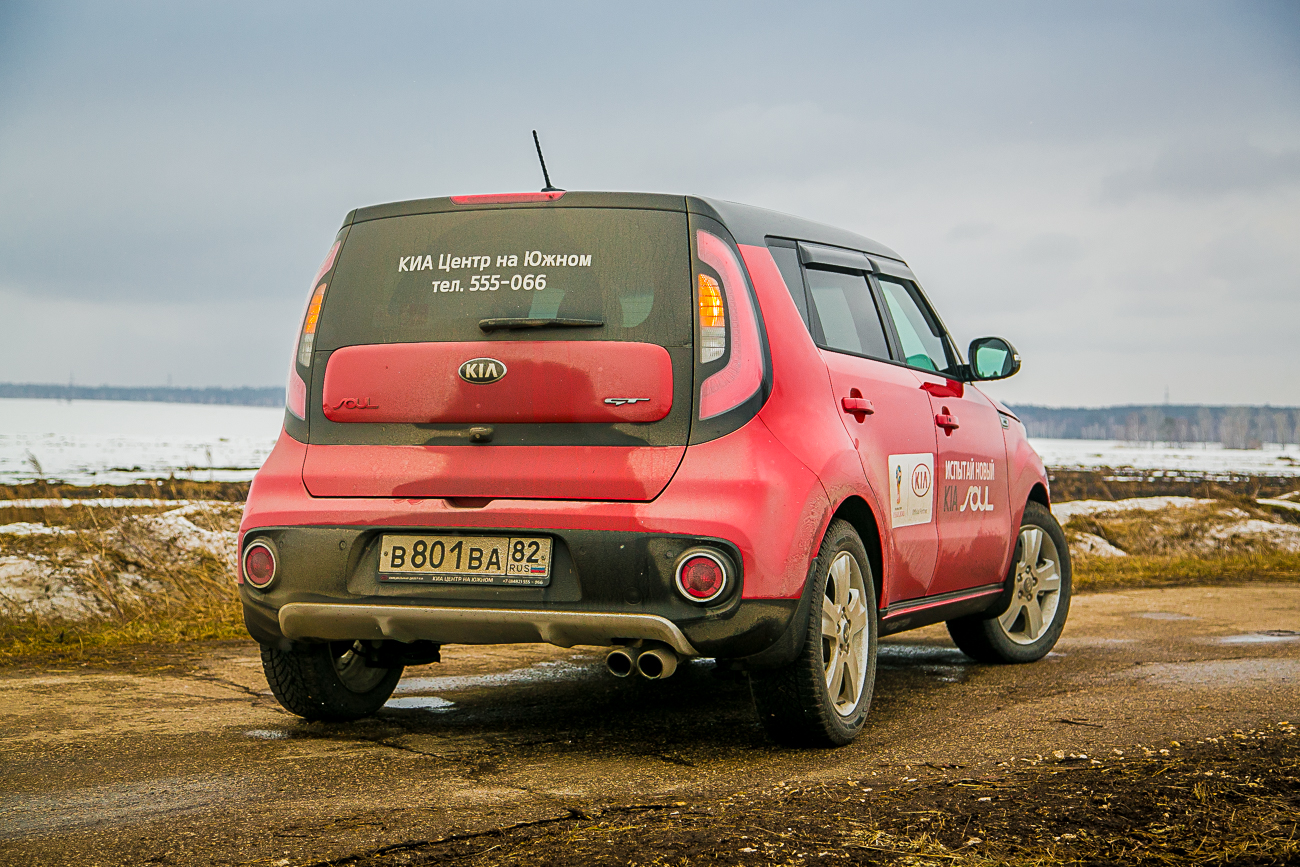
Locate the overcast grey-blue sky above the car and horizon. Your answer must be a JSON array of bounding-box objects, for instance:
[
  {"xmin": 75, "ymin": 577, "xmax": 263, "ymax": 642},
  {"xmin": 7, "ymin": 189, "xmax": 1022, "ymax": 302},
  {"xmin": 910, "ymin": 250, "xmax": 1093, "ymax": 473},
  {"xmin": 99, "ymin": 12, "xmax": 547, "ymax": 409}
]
[{"xmin": 0, "ymin": 0, "xmax": 1300, "ymax": 406}]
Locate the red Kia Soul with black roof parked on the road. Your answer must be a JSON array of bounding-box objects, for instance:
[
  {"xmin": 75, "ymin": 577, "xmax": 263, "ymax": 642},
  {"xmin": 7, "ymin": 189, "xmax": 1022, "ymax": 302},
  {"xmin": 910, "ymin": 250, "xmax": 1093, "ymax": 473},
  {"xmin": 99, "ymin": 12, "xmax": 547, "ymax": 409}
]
[{"xmin": 239, "ymin": 191, "xmax": 1070, "ymax": 745}]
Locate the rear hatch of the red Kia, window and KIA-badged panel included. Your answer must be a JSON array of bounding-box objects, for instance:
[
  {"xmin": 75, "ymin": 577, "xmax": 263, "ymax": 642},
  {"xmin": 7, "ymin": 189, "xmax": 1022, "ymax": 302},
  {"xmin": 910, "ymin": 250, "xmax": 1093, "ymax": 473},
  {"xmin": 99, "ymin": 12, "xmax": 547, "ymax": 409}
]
[{"xmin": 303, "ymin": 194, "xmax": 694, "ymax": 500}]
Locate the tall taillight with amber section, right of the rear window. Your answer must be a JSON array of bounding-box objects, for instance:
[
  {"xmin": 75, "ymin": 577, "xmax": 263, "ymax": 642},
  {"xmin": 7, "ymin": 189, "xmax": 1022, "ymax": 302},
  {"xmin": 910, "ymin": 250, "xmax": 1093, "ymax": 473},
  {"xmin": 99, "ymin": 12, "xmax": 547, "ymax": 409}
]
[{"xmin": 696, "ymin": 230, "xmax": 763, "ymax": 420}]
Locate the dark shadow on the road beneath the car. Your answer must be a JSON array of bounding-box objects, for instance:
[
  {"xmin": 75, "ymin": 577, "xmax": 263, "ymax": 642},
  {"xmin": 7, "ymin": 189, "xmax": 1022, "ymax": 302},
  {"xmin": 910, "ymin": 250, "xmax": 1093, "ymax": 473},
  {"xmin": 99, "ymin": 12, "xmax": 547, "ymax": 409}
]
[{"xmin": 253, "ymin": 642, "xmax": 978, "ymax": 764}]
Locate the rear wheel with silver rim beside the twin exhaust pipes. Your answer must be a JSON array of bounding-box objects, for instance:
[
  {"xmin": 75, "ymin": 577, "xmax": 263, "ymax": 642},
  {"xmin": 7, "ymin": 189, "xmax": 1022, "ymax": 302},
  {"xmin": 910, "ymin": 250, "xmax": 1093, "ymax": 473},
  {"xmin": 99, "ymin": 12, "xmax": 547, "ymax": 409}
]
[{"xmin": 750, "ymin": 520, "xmax": 878, "ymax": 746}]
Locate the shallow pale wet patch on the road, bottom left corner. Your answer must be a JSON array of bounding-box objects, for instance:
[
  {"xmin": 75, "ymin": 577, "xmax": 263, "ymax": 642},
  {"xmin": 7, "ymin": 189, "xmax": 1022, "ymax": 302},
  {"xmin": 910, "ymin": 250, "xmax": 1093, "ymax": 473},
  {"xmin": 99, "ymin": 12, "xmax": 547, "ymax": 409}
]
[{"xmin": 0, "ymin": 773, "xmax": 242, "ymax": 838}]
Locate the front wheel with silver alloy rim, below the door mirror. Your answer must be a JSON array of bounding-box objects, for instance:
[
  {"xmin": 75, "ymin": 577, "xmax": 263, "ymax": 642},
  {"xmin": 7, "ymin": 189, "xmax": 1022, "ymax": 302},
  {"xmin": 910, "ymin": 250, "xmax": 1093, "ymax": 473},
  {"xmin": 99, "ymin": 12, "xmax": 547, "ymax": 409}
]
[{"xmin": 948, "ymin": 502, "xmax": 1073, "ymax": 663}]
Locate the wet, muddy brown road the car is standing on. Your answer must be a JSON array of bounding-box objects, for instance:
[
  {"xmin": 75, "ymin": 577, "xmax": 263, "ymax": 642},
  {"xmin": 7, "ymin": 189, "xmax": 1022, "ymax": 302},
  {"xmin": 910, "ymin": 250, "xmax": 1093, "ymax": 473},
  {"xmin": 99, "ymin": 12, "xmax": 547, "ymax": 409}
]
[{"xmin": 0, "ymin": 585, "xmax": 1300, "ymax": 864}]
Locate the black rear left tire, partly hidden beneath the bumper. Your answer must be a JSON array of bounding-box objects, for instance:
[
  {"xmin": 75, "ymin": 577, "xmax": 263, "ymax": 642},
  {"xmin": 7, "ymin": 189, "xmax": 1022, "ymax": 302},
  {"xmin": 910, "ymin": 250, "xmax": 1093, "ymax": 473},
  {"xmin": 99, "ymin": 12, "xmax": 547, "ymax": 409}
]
[{"xmin": 261, "ymin": 641, "xmax": 402, "ymax": 723}]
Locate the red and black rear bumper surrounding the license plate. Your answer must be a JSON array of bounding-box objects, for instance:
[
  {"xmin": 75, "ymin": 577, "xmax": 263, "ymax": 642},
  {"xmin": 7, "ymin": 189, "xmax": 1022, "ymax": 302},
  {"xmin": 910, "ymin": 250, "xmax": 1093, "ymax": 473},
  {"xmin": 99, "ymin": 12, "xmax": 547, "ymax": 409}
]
[{"xmin": 239, "ymin": 420, "xmax": 829, "ymax": 659}]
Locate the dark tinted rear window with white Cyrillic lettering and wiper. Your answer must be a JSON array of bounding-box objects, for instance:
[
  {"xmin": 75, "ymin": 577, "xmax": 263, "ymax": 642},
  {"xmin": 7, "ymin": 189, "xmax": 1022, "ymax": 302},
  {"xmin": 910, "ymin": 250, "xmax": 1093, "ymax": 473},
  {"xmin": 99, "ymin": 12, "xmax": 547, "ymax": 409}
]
[{"xmin": 317, "ymin": 208, "xmax": 693, "ymax": 350}]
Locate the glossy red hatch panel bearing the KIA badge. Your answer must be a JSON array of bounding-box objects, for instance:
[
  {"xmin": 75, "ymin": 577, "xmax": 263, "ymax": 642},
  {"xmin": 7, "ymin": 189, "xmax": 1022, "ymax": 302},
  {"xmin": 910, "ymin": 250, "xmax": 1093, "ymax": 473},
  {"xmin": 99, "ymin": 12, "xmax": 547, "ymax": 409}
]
[{"xmin": 321, "ymin": 341, "xmax": 672, "ymax": 426}]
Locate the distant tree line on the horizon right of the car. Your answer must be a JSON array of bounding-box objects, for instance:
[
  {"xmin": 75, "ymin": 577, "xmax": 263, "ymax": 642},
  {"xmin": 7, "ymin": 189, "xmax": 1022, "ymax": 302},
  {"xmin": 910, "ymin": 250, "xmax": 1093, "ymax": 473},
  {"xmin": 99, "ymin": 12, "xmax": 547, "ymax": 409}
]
[{"xmin": 1013, "ymin": 406, "xmax": 1300, "ymax": 448}]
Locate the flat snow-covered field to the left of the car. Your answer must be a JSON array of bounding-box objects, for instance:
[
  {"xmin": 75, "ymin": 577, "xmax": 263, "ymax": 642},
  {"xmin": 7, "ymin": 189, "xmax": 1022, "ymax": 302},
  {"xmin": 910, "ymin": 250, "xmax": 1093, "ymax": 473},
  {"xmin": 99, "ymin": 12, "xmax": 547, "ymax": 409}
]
[{"xmin": 0, "ymin": 399, "xmax": 285, "ymax": 485}]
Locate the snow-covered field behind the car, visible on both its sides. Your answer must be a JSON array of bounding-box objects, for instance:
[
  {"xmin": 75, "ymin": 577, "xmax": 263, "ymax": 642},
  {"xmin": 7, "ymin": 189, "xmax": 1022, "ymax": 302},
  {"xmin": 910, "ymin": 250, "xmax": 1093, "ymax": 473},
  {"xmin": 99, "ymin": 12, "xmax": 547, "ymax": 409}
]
[{"xmin": 0, "ymin": 399, "xmax": 1300, "ymax": 485}]
